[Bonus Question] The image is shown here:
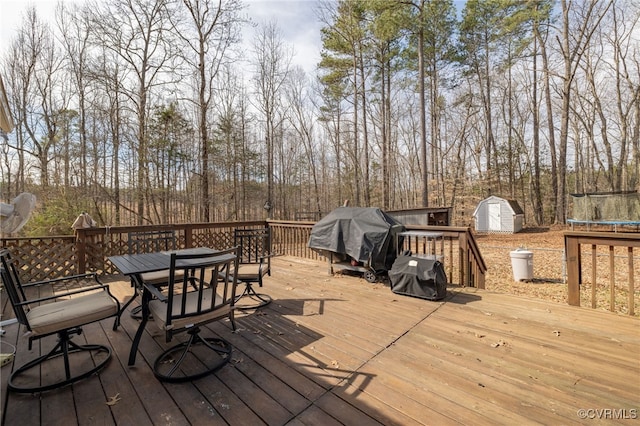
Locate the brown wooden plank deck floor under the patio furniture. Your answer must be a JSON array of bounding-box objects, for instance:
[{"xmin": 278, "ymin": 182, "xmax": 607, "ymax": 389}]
[{"xmin": 0, "ymin": 257, "xmax": 640, "ymax": 426}]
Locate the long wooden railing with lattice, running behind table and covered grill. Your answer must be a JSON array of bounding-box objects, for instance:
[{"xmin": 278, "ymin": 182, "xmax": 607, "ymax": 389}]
[{"xmin": 0, "ymin": 220, "xmax": 487, "ymax": 288}]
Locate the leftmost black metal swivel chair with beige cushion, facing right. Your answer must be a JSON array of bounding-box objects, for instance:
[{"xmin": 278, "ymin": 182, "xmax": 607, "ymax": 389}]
[{"xmin": 0, "ymin": 249, "xmax": 120, "ymax": 393}]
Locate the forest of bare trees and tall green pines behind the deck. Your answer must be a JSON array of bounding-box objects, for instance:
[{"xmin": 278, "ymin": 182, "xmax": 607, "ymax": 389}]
[{"xmin": 0, "ymin": 0, "xmax": 640, "ymax": 235}]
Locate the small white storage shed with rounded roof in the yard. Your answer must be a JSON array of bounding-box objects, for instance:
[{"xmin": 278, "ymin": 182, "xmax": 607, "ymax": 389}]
[{"xmin": 473, "ymin": 195, "xmax": 524, "ymax": 234}]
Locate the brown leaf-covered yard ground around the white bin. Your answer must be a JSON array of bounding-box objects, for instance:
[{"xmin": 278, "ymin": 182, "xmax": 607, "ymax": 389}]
[{"xmin": 475, "ymin": 226, "xmax": 640, "ymax": 316}]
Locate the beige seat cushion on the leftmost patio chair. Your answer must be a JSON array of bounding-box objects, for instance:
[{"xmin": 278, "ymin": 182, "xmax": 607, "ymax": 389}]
[{"xmin": 27, "ymin": 291, "xmax": 118, "ymax": 335}]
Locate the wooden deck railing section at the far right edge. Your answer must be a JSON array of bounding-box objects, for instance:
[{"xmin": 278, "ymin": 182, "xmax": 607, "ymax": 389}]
[{"xmin": 564, "ymin": 231, "xmax": 640, "ymax": 316}]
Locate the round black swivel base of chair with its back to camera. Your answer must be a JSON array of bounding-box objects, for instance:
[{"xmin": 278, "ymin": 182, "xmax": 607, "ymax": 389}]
[{"xmin": 153, "ymin": 327, "xmax": 233, "ymax": 383}]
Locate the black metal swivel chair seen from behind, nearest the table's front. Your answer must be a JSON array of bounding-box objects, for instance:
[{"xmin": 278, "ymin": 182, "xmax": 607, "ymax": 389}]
[{"xmin": 143, "ymin": 248, "xmax": 238, "ymax": 382}]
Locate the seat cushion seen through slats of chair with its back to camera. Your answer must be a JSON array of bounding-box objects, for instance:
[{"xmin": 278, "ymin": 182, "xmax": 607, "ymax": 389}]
[{"xmin": 149, "ymin": 289, "xmax": 231, "ymax": 330}]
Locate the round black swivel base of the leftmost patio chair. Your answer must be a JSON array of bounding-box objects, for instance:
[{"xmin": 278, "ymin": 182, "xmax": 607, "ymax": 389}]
[{"xmin": 7, "ymin": 329, "xmax": 111, "ymax": 393}]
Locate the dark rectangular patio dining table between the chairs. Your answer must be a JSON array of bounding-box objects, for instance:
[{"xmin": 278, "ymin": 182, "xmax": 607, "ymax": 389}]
[{"xmin": 109, "ymin": 247, "xmax": 218, "ymax": 366}]
